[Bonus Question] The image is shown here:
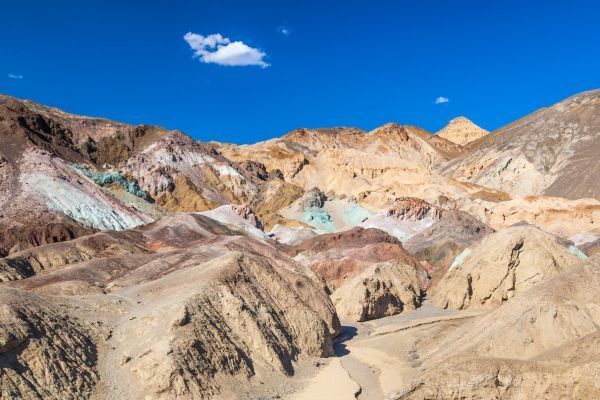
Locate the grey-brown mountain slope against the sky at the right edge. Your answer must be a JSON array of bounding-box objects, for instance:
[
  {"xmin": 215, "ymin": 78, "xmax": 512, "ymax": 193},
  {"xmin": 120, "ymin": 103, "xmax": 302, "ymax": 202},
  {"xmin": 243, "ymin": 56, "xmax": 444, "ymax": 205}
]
[{"xmin": 443, "ymin": 90, "xmax": 600, "ymax": 199}]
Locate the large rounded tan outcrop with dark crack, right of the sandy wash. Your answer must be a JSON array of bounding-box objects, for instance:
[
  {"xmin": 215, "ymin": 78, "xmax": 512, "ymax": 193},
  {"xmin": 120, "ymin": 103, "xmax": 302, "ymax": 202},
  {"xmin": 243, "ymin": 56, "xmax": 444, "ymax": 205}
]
[{"xmin": 431, "ymin": 226, "xmax": 579, "ymax": 310}]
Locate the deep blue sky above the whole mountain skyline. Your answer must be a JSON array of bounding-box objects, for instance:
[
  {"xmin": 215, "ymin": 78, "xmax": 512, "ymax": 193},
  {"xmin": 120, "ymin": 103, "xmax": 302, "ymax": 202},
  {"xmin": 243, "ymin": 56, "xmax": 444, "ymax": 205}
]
[{"xmin": 0, "ymin": 0, "xmax": 600, "ymax": 143}]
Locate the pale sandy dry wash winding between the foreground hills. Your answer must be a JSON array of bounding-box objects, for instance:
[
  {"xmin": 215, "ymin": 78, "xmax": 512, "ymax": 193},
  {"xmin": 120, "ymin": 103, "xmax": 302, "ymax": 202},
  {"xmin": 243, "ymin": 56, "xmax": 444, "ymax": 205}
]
[{"xmin": 295, "ymin": 302, "xmax": 477, "ymax": 400}]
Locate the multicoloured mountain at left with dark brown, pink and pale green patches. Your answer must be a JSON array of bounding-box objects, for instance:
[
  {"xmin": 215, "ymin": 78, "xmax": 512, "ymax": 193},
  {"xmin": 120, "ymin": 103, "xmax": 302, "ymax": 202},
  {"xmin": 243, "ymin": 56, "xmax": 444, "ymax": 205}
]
[{"xmin": 0, "ymin": 96, "xmax": 268, "ymax": 255}]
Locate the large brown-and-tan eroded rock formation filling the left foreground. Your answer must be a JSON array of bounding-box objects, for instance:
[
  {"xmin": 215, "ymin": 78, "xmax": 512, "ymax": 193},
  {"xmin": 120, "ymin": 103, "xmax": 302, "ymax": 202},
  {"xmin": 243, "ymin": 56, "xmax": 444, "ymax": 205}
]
[{"xmin": 0, "ymin": 214, "xmax": 339, "ymax": 398}]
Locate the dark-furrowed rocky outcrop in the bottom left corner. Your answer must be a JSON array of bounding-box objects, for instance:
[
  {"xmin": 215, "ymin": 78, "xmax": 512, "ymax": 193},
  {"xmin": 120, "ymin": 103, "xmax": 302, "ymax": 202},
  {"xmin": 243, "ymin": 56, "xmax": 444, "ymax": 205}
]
[{"xmin": 0, "ymin": 286, "xmax": 99, "ymax": 399}]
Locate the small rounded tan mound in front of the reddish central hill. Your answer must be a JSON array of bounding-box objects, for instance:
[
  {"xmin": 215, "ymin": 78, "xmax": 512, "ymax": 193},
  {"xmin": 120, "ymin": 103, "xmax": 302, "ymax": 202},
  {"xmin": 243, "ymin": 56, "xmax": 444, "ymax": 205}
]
[{"xmin": 331, "ymin": 261, "xmax": 426, "ymax": 322}]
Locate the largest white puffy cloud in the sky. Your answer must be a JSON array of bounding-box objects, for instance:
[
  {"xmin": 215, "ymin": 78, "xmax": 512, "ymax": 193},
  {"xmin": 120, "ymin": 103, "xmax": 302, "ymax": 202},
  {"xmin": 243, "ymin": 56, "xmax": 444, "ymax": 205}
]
[{"xmin": 183, "ymin": 32, "xmax": 269, "ymax": 68}]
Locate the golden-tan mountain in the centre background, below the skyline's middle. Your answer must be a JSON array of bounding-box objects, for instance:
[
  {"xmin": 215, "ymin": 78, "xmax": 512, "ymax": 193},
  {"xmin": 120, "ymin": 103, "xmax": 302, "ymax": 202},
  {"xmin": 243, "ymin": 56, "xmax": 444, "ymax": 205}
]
[{"xmin": 219, "ymin": 123, "xmax": 463, "ymax": 208}]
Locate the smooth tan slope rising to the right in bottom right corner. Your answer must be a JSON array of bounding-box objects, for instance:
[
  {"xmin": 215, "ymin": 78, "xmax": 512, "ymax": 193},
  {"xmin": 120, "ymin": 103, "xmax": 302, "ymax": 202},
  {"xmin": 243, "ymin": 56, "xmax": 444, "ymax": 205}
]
[{"xmin": 391, "ymin": 259, "xmax": 600, "ymax": 399}]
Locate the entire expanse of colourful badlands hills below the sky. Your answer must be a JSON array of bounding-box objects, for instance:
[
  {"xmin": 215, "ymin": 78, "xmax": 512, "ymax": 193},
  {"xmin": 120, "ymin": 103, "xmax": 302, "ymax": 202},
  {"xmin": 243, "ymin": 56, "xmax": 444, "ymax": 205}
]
[{"xmin": 0, "ymin": 91, "xmax": 600, "ymax": 399}]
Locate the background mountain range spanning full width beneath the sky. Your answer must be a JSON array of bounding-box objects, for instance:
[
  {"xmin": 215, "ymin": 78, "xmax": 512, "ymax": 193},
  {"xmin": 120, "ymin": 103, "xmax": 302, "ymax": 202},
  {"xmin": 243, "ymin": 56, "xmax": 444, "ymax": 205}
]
[{"xmin": 0, "ymin": 91, "xmax": 600, "ymax": 254}]
